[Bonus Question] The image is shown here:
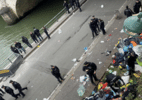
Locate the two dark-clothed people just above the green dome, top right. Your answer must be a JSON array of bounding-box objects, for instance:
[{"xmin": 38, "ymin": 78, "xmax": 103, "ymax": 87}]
[{"xmin": 124, "ymin": 0, "xmax": 141, "ymax": 17}]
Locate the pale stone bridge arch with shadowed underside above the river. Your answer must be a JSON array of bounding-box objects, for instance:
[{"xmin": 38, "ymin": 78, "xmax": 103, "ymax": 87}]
[{"xmin": 0, "ymin": 0, "xmax": 43, "ymax": 25}]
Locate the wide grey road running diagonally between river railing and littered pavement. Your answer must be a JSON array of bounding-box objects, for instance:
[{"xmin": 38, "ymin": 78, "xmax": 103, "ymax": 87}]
[{"xmin": 1, "ymin": 0, "xmax": 129, "ymax": 100}]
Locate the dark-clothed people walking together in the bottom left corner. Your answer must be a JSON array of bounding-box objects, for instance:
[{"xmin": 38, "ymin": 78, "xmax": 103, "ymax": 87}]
[{"xmin": 0, "ymin": 80, "xmax": 28, "ymax": 100}]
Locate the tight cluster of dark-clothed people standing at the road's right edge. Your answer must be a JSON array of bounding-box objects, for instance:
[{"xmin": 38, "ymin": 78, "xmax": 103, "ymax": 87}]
[{"xmin": 89, "ymin": 16, "xmax": 106, "ymax": 39}]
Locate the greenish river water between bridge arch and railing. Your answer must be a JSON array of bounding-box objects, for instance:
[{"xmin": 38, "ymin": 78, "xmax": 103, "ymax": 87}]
[{"xmin": 0, "ymin": 0, "xmax": 63, "ymax": 68}]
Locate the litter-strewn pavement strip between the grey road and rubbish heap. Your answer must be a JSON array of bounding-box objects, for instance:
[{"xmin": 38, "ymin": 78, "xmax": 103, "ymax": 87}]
[{"xmin": 50, "ymin": 1, "xmax": 136, "ymax": 100}]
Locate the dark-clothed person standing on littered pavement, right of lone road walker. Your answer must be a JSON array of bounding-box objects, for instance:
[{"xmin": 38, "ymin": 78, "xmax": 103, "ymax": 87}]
[{"xmin": 83, "ymin": 61, "xmax": 99, "ymax": 86}]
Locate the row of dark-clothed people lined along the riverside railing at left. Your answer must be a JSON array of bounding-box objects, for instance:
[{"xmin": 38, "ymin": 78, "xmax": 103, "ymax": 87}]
[{"xmin": 10, "ymin": 27, "xmax": 50, "ymax": 54}]
